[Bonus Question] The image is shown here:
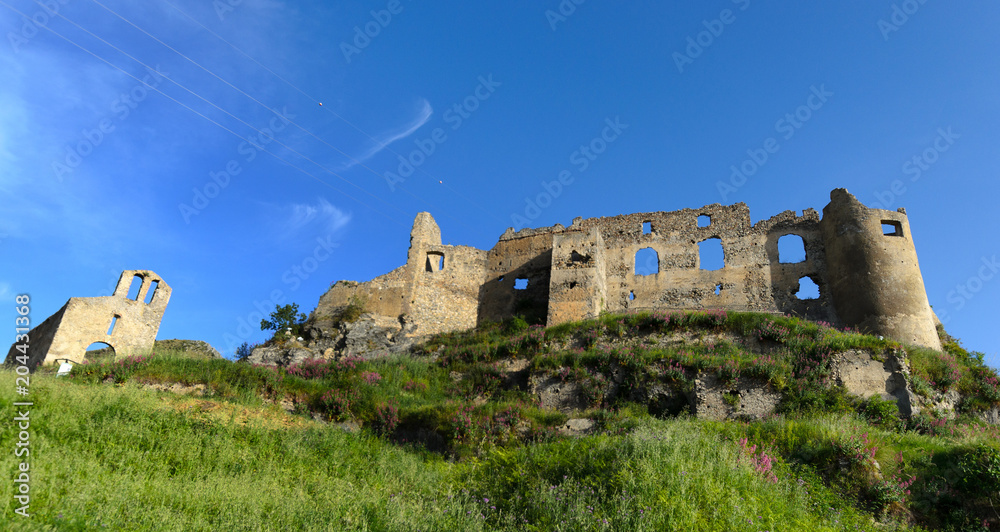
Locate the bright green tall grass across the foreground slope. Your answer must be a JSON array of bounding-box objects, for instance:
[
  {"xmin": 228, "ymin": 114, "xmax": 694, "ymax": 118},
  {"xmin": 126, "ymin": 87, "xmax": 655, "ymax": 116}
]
[{"xmin": 0, "ymin": 373, "xmax": 892, "ymax": 530}]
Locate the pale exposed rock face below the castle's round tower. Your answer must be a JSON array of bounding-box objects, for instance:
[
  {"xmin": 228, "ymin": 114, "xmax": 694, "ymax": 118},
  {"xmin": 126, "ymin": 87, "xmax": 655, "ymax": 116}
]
[{"xmin": 833, "ymin": 350, "xmax": 920, "ymax": 417}]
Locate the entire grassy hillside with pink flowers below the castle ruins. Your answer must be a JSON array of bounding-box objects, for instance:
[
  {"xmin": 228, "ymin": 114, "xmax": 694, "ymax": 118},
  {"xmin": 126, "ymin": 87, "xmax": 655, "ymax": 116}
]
[{"xmin": 0, "ymin": 313, "xmax": 1000, "ymax": 531}]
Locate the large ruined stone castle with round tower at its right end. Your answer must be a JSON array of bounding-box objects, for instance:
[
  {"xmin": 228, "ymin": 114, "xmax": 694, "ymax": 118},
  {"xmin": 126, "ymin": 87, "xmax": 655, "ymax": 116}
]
[{"xmin": 317, "ymin": 189, "xmax": 941, "ymax": 350}]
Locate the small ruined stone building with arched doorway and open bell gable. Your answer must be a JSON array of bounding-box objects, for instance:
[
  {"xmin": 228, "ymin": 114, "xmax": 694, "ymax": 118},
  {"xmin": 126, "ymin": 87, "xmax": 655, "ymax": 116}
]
[{"xmin": 7, "ymin": 270, "xmax": 170, "ymax": 368}]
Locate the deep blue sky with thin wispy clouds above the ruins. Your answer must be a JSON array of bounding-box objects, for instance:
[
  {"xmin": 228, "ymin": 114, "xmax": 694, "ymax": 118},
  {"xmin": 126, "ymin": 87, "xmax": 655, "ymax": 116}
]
[{"xmin": 0, "ymin": 0, "xmax": 1000, "ymax": 366}]
